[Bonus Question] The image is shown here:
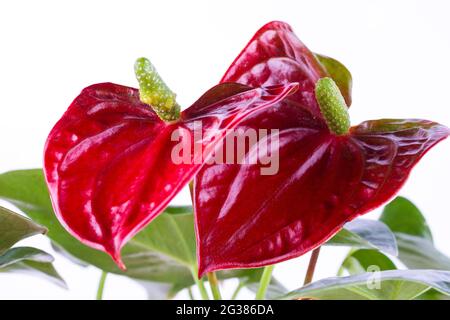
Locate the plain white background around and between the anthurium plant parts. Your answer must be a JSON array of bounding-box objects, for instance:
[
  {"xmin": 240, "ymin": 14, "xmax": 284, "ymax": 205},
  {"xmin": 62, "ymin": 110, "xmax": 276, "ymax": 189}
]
[{"xmin": 0, "ymin": 0, "xmax": 450, "ymax": 299}]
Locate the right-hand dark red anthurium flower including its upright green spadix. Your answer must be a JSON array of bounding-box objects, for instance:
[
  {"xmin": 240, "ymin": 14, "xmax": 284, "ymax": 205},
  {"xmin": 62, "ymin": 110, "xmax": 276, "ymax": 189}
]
[{"xmin": 194, "ymin": 22, "xmax": 449, "ymax": 275}]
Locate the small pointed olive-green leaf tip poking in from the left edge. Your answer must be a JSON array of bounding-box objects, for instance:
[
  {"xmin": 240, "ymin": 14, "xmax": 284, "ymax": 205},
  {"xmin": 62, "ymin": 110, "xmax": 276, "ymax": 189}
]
[{"xmin": 0, "ymin": 207, "xmax": 47, "ymax": 254}]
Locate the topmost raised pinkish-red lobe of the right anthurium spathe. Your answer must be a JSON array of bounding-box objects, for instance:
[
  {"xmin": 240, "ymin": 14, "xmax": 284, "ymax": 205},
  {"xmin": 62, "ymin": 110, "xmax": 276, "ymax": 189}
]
[{"xmin": 221, "ymin": 21, "xmax": 328, "ymax": 118}]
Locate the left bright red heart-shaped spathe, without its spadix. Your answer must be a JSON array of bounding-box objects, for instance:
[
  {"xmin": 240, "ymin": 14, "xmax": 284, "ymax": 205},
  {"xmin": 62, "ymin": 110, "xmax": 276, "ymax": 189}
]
[{"xmin": 44, "ymin": 83, "xmax": 297, "ymax": 268}]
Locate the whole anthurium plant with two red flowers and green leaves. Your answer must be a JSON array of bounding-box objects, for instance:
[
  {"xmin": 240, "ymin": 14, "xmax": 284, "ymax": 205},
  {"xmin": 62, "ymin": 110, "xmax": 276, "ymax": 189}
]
[{"xmin": 0, "ymin": 21, "xmax": 450, "ymax": 299}]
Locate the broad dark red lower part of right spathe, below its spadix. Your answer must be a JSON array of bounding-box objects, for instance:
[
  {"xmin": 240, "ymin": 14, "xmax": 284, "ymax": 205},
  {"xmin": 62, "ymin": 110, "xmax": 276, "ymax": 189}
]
[{"xmin": 194, "ymin": 117, "xmax": 449, "ymax": 275}]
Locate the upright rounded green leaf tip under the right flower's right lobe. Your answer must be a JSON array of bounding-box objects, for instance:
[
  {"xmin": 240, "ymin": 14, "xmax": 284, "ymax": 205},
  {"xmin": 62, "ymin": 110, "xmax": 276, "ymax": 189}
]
[{"xmin": 380, "ymin": 197, "xmax": 433, "ymax": 241}]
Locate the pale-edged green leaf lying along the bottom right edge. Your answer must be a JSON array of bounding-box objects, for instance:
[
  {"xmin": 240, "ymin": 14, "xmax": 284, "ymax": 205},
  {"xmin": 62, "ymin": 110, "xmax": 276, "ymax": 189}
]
[{"xmin": 281, "ymin": 270, "xmax": 450, "ymax": 300}]
